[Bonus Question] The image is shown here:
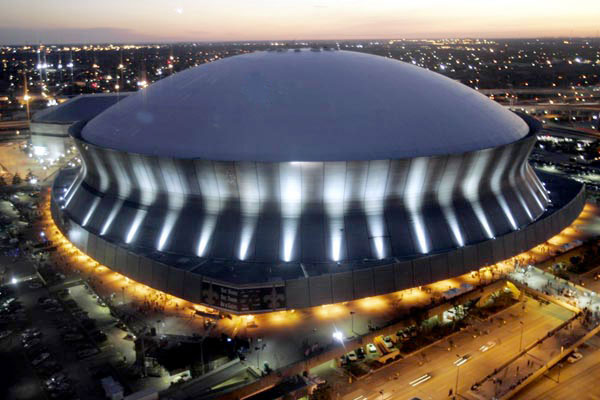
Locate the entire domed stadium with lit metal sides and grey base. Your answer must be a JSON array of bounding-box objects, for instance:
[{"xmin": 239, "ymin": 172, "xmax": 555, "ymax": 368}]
[{"xmin": 52, "ymin": 49, "xmax": 584, "ymax": 313}]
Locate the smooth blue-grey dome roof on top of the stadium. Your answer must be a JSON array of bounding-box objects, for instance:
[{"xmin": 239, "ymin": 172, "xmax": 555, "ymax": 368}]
[{"xmin": 81, "ymin": 50, "xmax": 529, "ymax": 162}]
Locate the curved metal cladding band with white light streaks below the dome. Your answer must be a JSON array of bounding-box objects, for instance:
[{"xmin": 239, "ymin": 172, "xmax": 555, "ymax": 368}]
[{"xmin": 65, "ymin": 126, "xmax": 548, "ymax": 264}]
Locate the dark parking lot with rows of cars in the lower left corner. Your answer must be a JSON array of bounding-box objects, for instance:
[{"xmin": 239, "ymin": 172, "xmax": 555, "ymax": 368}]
[{"xmin": 0, "ymin": 253, "xmax": 173, "ymax": 399}]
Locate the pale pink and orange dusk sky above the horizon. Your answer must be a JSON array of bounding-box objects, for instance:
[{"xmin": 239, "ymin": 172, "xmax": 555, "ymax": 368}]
[{"xmin": 0, "ymin": 0, "xmax": 600, "ymax": 44}]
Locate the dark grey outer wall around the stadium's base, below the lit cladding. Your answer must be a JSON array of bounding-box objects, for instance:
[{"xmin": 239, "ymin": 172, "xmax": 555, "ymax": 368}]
[{"xmin": 51, "ymin": 180, "xmax": 585, "ymax": 314}]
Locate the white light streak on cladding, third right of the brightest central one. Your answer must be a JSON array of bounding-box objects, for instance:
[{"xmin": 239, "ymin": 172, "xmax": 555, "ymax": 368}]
[{"xmin": 404, "ymin": 157, "xmax": 429, "ymax": 254}]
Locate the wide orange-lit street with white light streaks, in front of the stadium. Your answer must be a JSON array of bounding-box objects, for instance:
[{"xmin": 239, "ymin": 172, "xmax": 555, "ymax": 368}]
[{"xmin": 311, "ymin": 299, "xmax": 572, "ymax": 400}]
